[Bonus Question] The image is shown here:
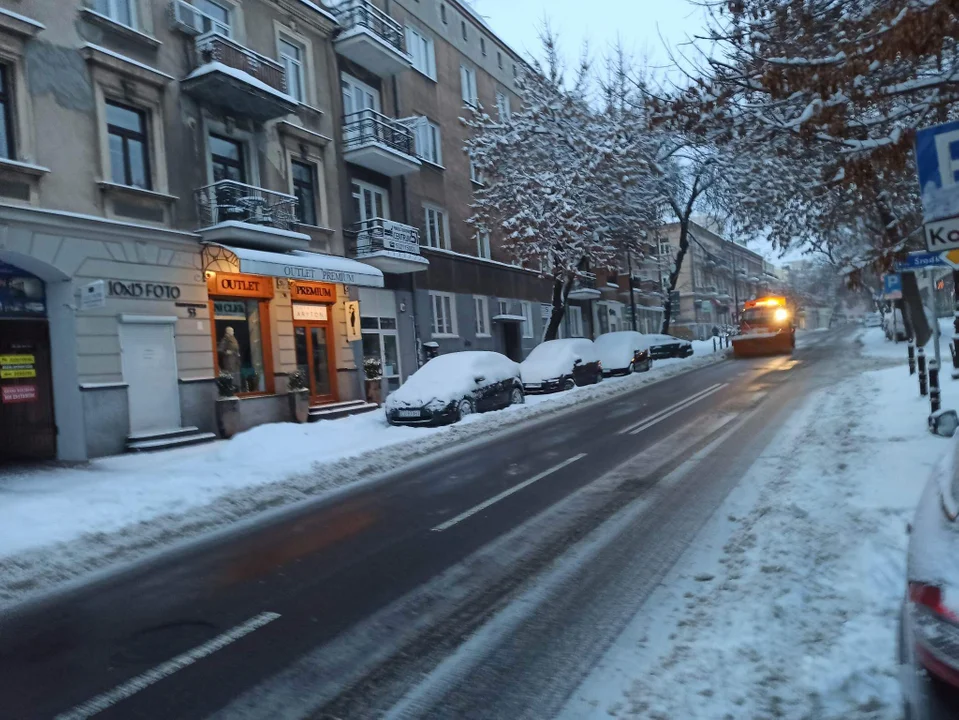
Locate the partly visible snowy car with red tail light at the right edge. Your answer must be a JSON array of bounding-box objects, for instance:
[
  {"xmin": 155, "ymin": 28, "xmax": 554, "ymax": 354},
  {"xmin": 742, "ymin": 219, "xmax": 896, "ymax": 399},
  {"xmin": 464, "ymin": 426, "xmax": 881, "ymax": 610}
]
[{"xmin": 899, "ymin": 420, "xmax": 959, "ymax": 720}]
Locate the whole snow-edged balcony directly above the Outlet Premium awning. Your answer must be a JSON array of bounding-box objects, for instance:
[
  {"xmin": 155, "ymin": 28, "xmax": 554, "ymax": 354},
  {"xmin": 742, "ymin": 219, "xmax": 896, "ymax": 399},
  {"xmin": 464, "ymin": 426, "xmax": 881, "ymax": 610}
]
[{"xmin": 196, "ymin": 180, "xmax": 310, "ymax": 251}]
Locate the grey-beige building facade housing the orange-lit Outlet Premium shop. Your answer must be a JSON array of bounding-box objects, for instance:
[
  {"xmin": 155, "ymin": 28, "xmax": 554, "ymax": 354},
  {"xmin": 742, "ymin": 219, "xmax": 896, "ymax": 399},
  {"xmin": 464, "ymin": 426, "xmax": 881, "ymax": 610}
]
[{"xmin": 0, "ymin": 0, "xmax": 383, "ymax": 460}]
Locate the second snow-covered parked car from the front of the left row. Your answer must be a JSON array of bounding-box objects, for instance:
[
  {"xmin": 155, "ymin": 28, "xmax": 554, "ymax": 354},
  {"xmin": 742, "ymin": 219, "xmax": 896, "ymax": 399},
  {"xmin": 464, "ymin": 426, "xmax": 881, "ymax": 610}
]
[{"xmin": 520, "ymin": 338, "xmax": 603, "ymax": 393}]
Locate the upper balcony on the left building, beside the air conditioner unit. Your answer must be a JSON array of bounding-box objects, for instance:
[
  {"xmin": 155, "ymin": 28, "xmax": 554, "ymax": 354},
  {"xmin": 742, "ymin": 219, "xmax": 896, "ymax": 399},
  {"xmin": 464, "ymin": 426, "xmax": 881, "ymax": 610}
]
[{"xmin": 181, "ymin": 32, "xmax": 297, "ymax": 122}]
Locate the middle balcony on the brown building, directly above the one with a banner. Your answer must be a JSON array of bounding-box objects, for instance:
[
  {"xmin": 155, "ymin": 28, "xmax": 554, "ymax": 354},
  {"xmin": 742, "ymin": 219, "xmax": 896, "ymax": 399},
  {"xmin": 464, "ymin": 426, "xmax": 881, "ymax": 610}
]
[{"xmin": 343, "ymin": 110, "xmax": 420, "ymax": 177}]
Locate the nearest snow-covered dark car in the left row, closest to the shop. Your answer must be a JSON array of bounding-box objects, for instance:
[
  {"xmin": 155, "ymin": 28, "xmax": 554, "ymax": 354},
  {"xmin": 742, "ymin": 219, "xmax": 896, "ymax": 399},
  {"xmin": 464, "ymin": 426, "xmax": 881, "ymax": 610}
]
[{"xmin": 386, "ymin": 350, "xmax": 524, "ymax": 425}]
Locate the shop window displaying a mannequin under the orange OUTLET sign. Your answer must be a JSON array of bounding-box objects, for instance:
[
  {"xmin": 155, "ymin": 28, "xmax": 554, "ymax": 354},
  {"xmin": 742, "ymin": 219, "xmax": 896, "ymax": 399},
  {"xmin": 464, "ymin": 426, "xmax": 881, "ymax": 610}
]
[{"xmin": 213, "ymin": 298, "xmax": 267, "ymax": 393}]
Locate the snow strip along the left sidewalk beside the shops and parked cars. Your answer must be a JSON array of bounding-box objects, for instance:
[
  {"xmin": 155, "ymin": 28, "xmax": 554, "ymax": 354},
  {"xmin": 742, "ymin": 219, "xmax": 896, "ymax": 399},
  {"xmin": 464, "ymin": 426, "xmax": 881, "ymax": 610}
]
[{"xmin": 0, "ymin": 346, "xmax": 724, "ymax": 608}]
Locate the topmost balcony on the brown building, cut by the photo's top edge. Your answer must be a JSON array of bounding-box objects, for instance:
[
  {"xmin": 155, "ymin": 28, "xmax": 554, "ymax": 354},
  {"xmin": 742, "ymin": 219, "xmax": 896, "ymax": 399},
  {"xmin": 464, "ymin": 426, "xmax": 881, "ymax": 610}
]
[{"xmin": 334, "ymin": 0, "xmax": 413, "ymax": 77}]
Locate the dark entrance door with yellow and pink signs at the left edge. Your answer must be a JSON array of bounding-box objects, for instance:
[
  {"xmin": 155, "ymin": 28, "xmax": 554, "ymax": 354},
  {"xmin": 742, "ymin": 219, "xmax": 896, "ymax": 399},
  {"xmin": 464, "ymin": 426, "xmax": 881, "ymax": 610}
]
[{"xmin": 0, "ymin": 320, "xmax": 57, "ymax": 462}]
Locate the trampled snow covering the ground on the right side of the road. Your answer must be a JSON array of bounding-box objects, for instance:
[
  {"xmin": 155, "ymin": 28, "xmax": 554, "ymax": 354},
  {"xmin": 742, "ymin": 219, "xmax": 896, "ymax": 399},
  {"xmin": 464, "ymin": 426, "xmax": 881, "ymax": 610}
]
[{"xmin": 578, "ymin": 352, "xmax": 959, "ymax": 720}]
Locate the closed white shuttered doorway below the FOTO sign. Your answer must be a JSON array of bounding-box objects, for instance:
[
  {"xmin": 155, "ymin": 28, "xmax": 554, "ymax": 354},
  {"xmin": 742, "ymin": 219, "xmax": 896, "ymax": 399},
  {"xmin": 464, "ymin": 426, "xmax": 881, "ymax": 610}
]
[{"xmin": 120, "ymin": 323, "xmax": 180, "ymax": 435}]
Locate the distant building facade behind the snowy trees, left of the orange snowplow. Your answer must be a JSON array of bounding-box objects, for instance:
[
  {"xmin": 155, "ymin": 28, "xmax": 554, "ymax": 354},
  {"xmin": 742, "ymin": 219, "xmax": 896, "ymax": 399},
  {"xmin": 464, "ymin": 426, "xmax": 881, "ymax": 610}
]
[{"xmin": 659, "ymin": 222, "xmax": 779, "ymax": 340}]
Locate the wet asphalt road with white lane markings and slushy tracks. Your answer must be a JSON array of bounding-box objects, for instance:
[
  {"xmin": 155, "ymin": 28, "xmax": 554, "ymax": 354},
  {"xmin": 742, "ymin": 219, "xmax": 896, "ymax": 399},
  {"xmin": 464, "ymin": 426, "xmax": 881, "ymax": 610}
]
[{"xmin": 0, "ymin": 332, "xmax": 849, "ymax": 720}]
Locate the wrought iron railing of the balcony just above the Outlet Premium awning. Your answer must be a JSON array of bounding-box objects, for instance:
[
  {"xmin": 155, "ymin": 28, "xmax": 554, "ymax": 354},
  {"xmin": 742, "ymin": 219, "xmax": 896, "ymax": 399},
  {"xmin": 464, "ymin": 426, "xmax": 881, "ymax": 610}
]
[{"xmin": 196, "ymin": 180, "xmax": 297, "ymax": 231}]
